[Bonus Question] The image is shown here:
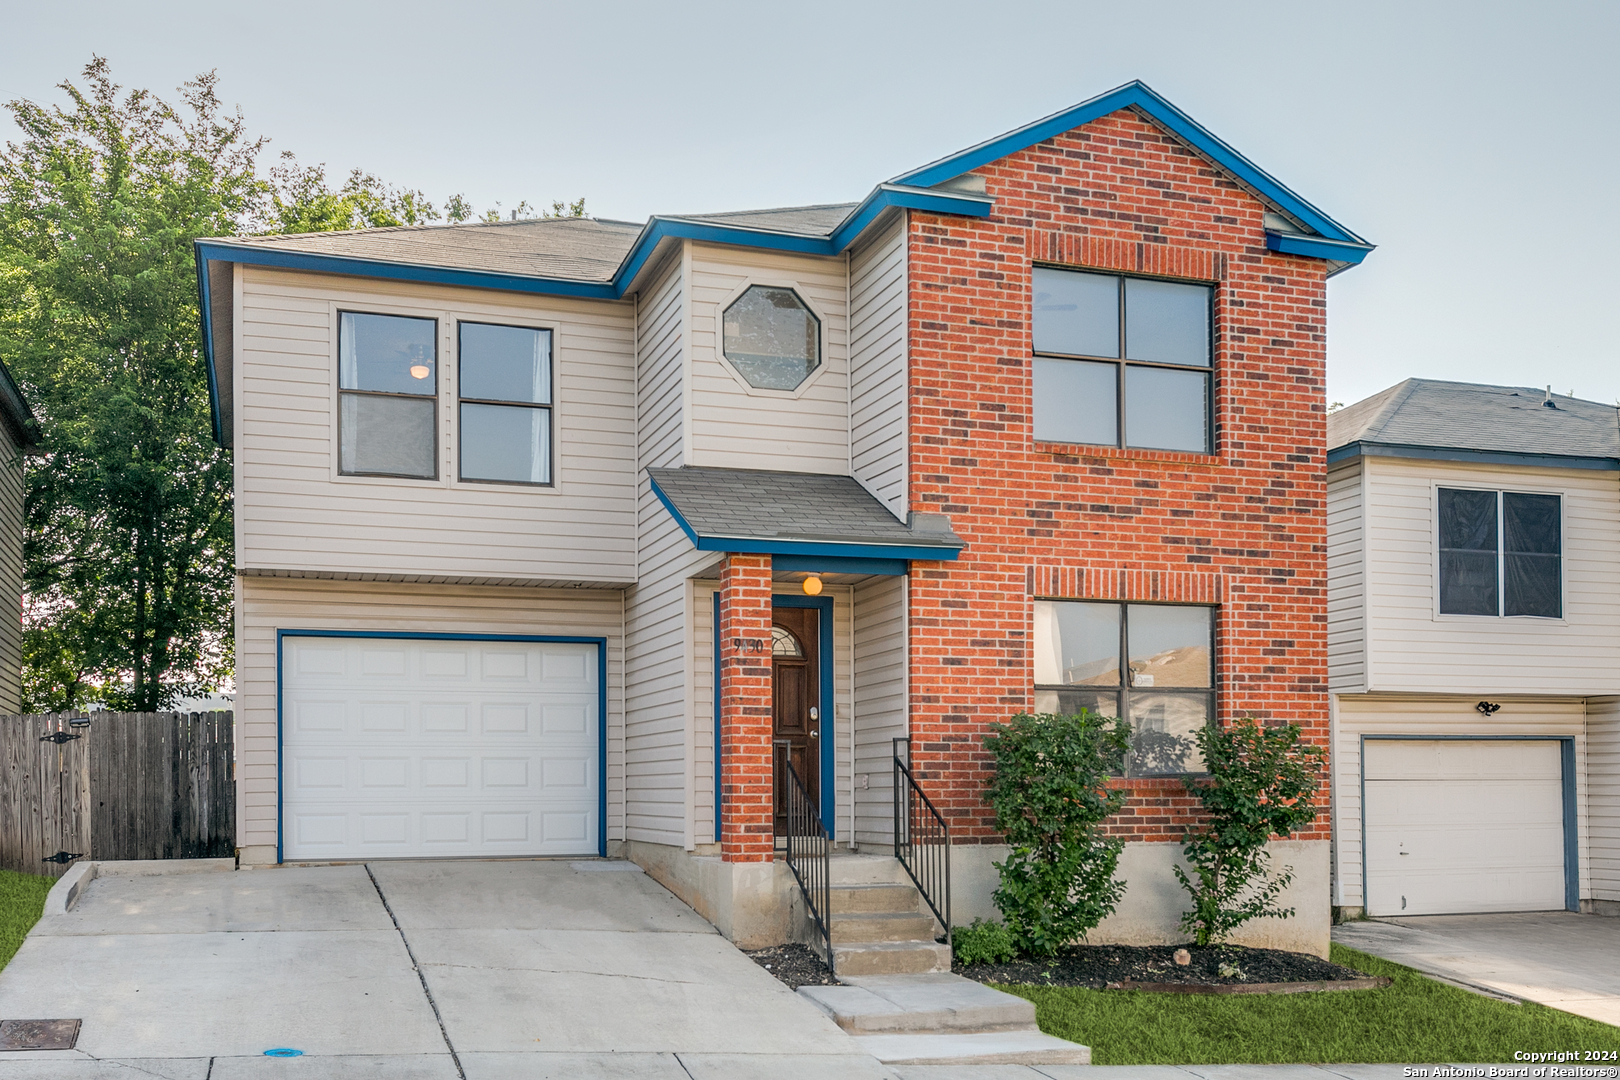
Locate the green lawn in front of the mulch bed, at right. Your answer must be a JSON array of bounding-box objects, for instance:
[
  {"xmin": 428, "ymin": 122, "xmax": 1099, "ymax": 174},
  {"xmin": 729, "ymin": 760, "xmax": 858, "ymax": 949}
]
[{"xmin": 1000, "ymin": 946, "xmax": 1620, "ymax": 1065}]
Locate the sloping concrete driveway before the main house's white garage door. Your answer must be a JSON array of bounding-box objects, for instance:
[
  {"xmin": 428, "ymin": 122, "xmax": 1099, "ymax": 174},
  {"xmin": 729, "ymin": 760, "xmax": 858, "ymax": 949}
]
[{"xmin": 0, "ymin": 860, "xmax": 894, "ymax": 1080}]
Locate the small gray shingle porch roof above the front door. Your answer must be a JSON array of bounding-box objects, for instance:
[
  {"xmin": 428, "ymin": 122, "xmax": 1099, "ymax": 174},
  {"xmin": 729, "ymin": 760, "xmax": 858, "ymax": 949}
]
[{"xmin": 646, "ymin": 465, "xmax": 962, "ymax": 557}]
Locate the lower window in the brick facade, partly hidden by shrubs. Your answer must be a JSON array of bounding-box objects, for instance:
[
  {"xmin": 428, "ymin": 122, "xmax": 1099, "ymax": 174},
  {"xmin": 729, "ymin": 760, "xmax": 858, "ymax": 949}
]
[{"xmin": 1035, "ymin": 601, "xmax": 1215, "ymax": 776}]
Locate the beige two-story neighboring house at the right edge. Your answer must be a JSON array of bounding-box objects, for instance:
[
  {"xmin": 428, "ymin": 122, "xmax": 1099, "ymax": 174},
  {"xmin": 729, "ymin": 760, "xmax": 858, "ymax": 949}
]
[{"xmin": 1328, "ymin": 379, "xmax": 1620, "ymax": 915}]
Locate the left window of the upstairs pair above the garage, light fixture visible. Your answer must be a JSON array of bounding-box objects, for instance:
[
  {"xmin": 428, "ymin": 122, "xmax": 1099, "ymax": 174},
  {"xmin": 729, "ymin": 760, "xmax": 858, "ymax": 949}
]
[{"xmin": 337, "ymin": 311, "xmax": 439, "ymax": 479}]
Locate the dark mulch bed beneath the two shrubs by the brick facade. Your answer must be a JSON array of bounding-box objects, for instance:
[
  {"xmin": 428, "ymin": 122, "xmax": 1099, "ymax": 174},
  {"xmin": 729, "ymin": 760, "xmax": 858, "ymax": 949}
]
[{"xmin": 951, "ymin": 946, "xmax": 1367, "ymax": 989}]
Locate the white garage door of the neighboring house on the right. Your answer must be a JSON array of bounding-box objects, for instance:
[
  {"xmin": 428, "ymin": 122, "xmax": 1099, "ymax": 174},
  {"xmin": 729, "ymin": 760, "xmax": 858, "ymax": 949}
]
[{"xmin": 1362, "ymin": 738, "xmax": 1563, "ymax": 915}]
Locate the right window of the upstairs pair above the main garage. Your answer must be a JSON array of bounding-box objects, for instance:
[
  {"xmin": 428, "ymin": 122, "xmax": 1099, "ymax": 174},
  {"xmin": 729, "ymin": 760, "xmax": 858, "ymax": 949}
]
[{"xmin": 458, "ymin": 322, "xmax": 551, "ymax": 484}]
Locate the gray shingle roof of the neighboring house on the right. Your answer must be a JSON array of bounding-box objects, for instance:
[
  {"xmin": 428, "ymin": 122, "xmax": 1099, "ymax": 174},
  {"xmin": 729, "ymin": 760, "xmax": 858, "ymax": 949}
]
[{"xmin": 1327, "ymin": 379, "xmax": 1620, "ymax": 458}]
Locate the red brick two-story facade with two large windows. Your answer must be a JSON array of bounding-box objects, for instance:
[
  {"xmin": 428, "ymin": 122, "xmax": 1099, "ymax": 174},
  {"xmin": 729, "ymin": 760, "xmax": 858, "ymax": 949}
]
[{"xmin": 909, "ymin": 112, "xmax": 1328, "ymax": 842}]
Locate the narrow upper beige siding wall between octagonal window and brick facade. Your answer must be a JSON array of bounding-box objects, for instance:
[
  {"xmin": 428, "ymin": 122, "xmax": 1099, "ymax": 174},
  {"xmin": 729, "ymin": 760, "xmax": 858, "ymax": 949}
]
[{"xmin": 849, "ymin": 210, "xmax": 909, "ymax": 521}]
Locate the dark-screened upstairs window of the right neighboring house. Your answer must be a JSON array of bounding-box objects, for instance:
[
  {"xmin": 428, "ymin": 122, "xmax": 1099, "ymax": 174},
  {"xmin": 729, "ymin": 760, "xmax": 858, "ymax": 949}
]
[{"xmin": 1440, "ymin": 487, "xmax": 1563, "ymax": 619}]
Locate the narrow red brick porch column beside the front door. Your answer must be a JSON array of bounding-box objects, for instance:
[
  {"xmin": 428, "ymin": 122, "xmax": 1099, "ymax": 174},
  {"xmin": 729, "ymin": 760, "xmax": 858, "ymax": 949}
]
[{"xmin": 719, "ymin": 555, "xmax": 776, "ymax": 863}]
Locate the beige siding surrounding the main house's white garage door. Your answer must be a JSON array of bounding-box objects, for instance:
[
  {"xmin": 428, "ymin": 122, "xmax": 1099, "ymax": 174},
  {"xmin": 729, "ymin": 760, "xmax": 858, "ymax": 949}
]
[{"xmin": 237, "ymin": 578, "xmax": 624, "ymax": 847}]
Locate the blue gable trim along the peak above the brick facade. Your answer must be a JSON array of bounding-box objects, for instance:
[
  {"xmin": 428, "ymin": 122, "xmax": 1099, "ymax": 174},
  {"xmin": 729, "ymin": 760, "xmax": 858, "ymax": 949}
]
[{"xmin": 893, "ymin": 79, "xmax": 1371, "ymax": 249}]
